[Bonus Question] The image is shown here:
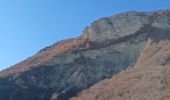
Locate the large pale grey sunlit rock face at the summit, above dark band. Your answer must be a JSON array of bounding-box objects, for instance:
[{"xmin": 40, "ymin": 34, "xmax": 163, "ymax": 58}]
[{"xmin": 83, "ymin": 12, "xmax": 152, "ymax": 41}]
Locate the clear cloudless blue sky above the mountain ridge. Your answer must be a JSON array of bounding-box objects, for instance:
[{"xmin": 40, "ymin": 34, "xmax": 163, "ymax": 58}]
[{"xmin": 0, "ymin": 0, "xmax": 170, "ymax": 70}]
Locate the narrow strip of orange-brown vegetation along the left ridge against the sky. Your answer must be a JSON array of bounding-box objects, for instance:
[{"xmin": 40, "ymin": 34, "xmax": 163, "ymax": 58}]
[{"xmin": 0, "ymin": 38, "xmax": 89, "ymax": 77}]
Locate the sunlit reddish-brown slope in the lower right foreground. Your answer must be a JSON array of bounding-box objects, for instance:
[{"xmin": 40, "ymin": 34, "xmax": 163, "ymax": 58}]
[{"xmin": 72, "ymin": 41, "xmax": 170, "ymax": 100}]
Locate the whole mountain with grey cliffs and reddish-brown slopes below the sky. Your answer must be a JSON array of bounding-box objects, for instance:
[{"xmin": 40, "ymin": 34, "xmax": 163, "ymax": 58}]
[{"xmin": 0, "ymin": 9, "xmax": 170, "ymax": 100}]
